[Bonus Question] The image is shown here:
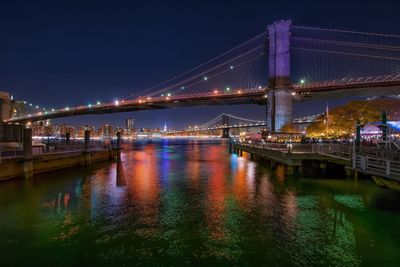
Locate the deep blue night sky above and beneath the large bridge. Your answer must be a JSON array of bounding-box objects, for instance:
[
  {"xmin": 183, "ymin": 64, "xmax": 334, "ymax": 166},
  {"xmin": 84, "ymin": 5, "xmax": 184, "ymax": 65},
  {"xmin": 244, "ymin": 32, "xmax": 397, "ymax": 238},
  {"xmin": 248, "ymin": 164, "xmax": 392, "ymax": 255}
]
[{"xmin": 0, "ymin": 0, "xmax": 400, "ymax": 128}]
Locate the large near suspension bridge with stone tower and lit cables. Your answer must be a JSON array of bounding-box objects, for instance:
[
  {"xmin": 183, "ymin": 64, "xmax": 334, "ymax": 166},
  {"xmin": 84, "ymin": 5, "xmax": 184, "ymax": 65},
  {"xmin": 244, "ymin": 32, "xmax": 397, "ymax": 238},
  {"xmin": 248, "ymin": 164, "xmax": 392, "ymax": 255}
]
[{"xmin": 4, "ymin": 20, "xmax": 400, "ymax": 131}]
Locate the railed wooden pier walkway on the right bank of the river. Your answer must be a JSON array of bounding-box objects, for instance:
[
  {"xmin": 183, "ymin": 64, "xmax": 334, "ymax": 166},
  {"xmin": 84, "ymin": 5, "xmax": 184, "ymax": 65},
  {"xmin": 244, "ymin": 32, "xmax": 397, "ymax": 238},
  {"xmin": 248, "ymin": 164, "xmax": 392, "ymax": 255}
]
[{"xmin": 233, "ymin": 142, "xmax": 400, "ymax": 182}]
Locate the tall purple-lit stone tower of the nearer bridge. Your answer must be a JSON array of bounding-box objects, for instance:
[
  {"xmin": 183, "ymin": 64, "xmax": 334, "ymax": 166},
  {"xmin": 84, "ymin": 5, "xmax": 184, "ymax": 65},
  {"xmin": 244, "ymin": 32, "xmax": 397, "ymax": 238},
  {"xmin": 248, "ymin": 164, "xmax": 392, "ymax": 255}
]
[{"xmin": 267, "ymin": 20, "xmax": 293, "ymax": 131}]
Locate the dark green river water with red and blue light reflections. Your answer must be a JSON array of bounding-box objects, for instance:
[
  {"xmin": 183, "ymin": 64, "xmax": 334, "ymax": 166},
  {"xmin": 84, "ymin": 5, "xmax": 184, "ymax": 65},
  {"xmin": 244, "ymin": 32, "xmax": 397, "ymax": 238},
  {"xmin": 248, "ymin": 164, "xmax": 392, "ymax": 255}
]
[{"xmin": 0, "ymin": 139, "xmax": 400, "ymax": 266}]
